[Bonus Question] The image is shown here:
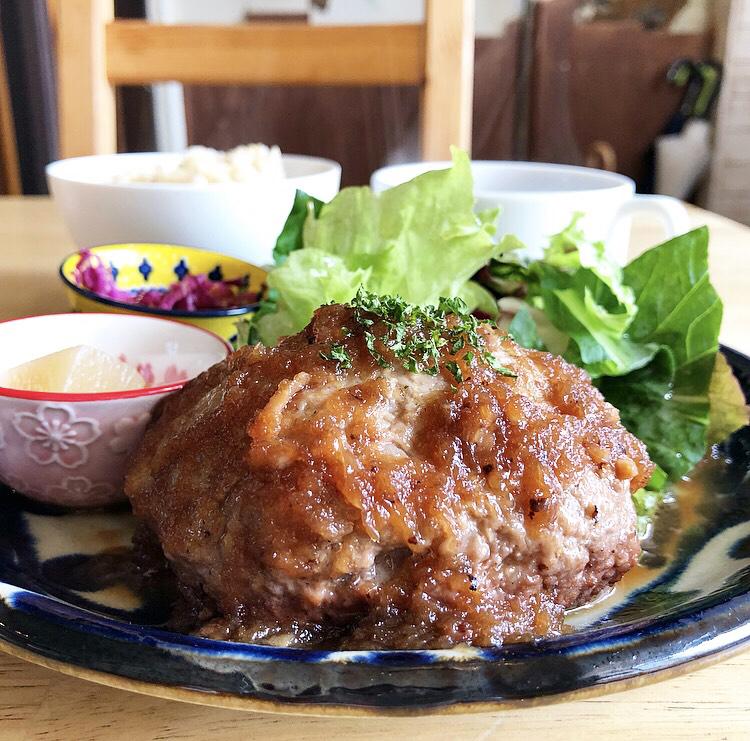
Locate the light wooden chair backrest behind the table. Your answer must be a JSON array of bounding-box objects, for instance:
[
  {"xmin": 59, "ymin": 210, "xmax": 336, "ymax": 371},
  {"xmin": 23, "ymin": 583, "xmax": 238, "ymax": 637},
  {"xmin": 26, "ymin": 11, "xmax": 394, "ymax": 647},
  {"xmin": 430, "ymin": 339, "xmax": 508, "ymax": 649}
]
[{"xmin": 56, "ymin": 0, "xmax": 474, "ymax": 159}]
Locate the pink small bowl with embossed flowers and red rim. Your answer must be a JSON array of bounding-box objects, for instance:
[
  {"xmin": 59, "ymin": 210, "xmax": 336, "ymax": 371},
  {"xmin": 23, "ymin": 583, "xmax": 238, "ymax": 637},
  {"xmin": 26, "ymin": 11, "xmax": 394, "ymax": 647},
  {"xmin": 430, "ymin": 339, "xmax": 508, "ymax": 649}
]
[{"xmin": 0, "ymin": 314, "xmax": 231, "ymax": 507}]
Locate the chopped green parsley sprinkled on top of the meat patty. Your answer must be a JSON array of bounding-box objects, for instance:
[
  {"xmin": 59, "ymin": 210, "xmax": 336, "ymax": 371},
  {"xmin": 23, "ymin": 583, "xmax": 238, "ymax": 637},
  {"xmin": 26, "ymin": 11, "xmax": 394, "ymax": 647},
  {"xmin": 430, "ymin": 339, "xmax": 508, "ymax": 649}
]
[{"xmin": 320, "ymin": 288, "xmax": 516, "ymax": 383}]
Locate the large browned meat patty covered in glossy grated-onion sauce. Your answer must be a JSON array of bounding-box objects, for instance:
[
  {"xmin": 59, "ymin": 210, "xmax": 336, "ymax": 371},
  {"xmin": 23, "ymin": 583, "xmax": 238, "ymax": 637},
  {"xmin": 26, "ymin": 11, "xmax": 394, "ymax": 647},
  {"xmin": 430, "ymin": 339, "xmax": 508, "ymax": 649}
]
[{"xmin": 126, "ymin": 306, "xmax": 653, "ymax": 648}]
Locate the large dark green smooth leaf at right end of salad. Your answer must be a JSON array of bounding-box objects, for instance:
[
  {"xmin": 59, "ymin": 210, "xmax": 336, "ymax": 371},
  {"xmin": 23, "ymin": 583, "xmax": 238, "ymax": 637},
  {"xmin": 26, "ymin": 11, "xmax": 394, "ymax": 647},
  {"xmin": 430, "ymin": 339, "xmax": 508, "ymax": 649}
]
[{"xmin": 600, "ymin": 227, "xmax": 722, "ymax": 480}]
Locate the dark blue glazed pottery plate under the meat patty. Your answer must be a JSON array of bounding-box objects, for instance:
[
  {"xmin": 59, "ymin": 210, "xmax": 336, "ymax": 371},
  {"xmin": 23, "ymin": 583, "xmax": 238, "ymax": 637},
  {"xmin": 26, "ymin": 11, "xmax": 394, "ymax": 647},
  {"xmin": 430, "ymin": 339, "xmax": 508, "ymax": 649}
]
[{"xmin": 0, "ymin": 350, "xmax": 750, "ymax": 714}]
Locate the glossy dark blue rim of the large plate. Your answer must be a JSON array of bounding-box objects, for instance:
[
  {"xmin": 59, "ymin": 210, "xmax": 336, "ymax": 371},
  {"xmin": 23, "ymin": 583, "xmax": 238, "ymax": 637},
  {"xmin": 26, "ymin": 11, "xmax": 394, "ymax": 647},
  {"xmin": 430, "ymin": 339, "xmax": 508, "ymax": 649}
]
[{"xmin": 0, "ymin": 348, "xmax": 750, "ymax": 714}]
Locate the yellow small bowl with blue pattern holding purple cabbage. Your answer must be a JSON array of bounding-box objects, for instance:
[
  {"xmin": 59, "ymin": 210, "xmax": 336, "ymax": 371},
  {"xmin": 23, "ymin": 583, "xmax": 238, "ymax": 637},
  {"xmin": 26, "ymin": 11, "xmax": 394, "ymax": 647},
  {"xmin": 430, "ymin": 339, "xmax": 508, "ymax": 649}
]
[{"xmin": 60, "ymin": 244, "xmax": 266, "ymax": 341}]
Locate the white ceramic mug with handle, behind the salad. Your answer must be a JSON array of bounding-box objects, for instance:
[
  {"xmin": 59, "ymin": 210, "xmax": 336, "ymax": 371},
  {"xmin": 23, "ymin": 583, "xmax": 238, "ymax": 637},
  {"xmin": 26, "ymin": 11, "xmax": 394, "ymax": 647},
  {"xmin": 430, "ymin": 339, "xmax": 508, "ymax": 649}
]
[{"xmin": 370, "ymin": 160, "xmax": 690, "ymax": 264}]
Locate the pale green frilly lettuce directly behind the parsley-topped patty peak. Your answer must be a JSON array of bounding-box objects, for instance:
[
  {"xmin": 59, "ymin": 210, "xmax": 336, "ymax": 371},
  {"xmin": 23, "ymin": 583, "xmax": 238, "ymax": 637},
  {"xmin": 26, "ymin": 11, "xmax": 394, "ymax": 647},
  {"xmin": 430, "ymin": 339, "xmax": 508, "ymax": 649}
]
[{"xmin": 256, "ymin": 149, "xmax": 518, "ymax": 344}]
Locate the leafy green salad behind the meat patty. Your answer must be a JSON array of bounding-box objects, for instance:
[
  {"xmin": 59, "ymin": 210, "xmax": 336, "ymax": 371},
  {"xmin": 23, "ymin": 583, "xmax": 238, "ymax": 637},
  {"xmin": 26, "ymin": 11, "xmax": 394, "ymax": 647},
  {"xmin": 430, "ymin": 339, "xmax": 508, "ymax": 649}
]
[{"xmin": 248, "ymin": 150, "xmax": 747, "ymax": 530}]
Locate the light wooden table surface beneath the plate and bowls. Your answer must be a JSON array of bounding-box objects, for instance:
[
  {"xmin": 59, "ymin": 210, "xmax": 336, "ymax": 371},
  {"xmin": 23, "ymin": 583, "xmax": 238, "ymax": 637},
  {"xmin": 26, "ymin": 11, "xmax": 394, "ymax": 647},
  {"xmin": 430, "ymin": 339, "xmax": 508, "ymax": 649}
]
[{"xmin": 0, "ymin": 197, "xmax": 750, "ymax": 741}]
